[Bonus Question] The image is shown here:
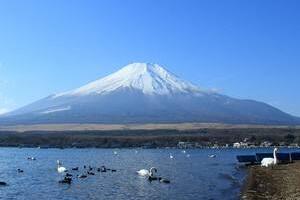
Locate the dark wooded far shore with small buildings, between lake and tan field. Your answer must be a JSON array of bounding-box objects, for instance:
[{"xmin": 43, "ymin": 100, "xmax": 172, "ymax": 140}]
[{"xmin": 0, "ymin": 128, "xmax": 300, "ymax": 149}]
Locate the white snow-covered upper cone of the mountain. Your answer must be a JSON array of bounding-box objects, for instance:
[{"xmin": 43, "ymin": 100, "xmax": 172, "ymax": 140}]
[{"xmin": 55, "ymin": 63, "xmax": 203, "ymax": 97}]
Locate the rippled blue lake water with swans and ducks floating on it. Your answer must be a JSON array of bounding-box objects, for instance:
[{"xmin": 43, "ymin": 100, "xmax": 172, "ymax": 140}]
[{"xmin": 0, "ymin": 148, "xmax": 292, "ymax": 200}]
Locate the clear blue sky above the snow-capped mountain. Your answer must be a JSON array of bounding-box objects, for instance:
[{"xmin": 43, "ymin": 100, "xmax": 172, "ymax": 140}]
[{"xmin": 0, "ymin": 0, "xmax": 300, "ymax": 116}]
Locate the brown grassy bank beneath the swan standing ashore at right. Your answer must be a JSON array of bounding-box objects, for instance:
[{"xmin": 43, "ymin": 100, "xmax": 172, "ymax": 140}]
[{"xmin": 242, "ymin": 162, "xmax": 300, "ymax": 200}]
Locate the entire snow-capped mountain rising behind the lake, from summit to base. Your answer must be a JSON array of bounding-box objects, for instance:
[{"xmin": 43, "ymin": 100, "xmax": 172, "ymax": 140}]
[{"xmin": 0, "ymin": 63, "xmax": 300, "ymax": 125}]
